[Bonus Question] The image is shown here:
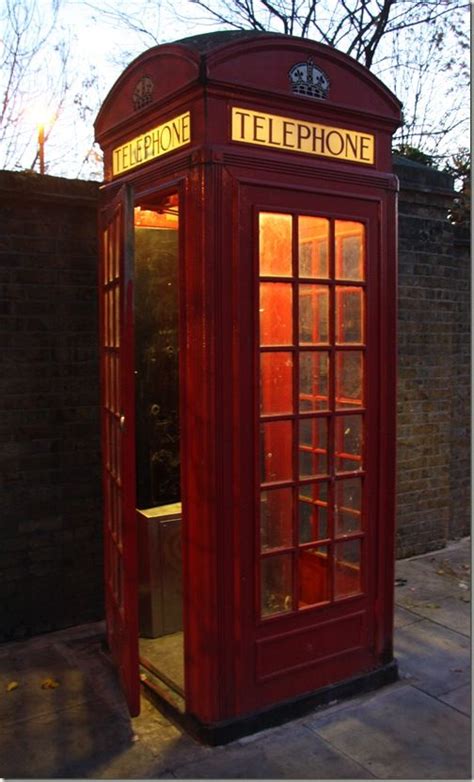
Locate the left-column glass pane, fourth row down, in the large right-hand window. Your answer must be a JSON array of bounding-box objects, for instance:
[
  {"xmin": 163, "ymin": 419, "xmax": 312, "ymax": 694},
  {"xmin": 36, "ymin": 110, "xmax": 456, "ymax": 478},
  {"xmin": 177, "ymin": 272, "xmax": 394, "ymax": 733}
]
[{"xmin": 260, "ymin": 421, "xmax": 293, "ymax": 483}]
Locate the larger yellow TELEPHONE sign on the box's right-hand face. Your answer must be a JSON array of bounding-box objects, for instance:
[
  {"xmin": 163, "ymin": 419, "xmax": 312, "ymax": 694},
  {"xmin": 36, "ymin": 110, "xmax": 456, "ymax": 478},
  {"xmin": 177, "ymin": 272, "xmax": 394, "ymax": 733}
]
[{"xmin": 231, "ymin": 106, "xmax": 375, "ymax": 165}]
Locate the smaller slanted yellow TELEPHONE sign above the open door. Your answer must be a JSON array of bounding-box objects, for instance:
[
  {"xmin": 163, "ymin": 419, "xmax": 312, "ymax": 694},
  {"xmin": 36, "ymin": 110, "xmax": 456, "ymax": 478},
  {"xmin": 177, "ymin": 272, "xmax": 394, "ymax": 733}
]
[{"xmin": 112, "ymin": 111, "xmax": 191, "ymax": 176}]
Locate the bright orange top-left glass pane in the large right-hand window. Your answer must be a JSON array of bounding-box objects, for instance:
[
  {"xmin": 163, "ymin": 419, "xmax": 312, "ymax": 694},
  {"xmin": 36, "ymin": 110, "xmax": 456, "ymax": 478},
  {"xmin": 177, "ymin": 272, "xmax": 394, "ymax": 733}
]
[{"xmin": 259, "ymin": 212, "xmax": 292, "ymax": 277}]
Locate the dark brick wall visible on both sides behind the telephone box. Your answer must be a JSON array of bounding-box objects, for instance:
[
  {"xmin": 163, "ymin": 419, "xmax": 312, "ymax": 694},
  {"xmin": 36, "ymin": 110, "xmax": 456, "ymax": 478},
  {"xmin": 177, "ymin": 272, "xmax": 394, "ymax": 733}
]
[{"xmin": 0, "ymin": 160, "xmax": 470, "ymax": 640}]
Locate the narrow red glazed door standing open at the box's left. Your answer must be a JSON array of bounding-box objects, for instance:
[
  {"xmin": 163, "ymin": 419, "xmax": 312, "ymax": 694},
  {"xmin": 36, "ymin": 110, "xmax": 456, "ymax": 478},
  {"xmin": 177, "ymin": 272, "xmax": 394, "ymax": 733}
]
[{"xmin": 99, "ymin": 186, "xmax": 140, "ymax": 717}]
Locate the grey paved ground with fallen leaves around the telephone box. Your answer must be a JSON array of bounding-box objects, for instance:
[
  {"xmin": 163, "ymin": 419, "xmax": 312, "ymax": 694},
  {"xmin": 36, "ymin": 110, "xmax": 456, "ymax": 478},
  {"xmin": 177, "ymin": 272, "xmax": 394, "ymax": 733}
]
[{"xmin": 0, "ymin": 539, "xmax": 471, "ymax": 780}]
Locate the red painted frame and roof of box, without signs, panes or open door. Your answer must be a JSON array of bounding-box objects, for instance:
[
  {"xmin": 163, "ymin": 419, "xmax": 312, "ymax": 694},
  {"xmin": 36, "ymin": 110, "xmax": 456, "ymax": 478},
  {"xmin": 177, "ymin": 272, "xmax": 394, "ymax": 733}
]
[{"xmin": 96, "ymin": 30, "xmax": 400, "ymax": 724}]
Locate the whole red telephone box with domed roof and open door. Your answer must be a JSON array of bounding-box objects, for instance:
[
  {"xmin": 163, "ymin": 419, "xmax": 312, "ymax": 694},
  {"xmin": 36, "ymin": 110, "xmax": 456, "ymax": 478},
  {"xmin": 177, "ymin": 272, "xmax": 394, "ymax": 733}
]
[{"xmin": 96, "ymin": 32, "xmax": 400, "ymax": 743}]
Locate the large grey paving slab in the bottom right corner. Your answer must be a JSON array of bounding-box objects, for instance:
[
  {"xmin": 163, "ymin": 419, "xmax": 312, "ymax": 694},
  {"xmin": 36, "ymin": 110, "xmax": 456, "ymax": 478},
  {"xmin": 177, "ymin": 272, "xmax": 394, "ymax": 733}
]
[{"xmin": 311, "ymin": 686, "xmax": 471, "ymax": 779}]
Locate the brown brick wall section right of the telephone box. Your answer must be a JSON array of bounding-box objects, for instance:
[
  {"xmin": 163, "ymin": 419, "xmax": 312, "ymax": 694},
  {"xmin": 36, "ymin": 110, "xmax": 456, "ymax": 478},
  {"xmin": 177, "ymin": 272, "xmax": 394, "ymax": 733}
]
[{"xmin": 395, "ymin": 159, "xmax": 470, "ymax": 557}]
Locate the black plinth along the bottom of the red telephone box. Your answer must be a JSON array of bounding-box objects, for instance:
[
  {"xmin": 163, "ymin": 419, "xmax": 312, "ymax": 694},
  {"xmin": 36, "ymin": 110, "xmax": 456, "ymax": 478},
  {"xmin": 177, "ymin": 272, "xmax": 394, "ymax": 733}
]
[{"xmin": 142, "ymin": 660, "xmax": 398, "ymax": 746}]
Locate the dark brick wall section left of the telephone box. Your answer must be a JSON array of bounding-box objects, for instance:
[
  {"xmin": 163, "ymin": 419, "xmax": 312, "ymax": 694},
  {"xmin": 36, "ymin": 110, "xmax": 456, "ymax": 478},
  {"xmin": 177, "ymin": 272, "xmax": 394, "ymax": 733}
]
[{"xmin": 0, "ymin": 172, "xmax": 103, "ymax": 640}]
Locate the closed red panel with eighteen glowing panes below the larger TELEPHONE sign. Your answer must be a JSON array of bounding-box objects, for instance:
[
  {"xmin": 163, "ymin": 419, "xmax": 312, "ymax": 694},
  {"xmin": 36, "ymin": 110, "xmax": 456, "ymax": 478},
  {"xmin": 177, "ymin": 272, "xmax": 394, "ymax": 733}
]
[{"xmin": 234, "ymin": 186, "xmax": 394, "ymax": 710}]
